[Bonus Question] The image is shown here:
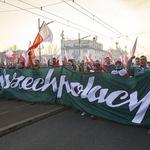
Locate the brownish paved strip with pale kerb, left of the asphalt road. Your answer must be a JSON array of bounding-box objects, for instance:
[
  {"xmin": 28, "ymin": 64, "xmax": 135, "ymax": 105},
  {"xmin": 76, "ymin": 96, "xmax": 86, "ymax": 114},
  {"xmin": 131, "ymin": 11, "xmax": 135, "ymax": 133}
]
[{"xmin": 0, "ymin": 98, "xmax": 66, "ymax": 137}]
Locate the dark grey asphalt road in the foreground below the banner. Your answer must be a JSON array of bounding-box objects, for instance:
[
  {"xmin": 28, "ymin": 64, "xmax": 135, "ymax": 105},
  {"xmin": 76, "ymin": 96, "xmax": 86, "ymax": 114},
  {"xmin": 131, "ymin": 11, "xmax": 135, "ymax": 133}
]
[{"xmin": 0, "ymin": 110, "xmax": 150, "ymax": 150}]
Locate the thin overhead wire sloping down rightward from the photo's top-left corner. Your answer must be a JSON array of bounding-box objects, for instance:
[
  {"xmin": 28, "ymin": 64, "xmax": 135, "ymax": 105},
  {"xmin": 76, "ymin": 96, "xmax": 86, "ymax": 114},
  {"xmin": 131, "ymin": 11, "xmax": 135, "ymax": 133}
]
[{"xmin": 0, "ymin": 1, "xmax": 105, "ymax": 41}]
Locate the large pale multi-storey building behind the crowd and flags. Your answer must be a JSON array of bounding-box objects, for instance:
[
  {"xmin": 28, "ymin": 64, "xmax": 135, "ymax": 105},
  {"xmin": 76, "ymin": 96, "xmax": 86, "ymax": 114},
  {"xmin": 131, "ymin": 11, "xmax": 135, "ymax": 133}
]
[{"xmin": 61, "ymin": 39, "xmax": 106, "ymax": 60}]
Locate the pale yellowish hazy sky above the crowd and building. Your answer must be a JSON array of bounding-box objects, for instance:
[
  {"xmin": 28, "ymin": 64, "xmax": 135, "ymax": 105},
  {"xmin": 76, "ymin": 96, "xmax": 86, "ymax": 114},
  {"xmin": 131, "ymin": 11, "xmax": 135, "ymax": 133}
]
[{"xmin": 0, "ymin": 0, "xmax": 150, "ymax": 55}]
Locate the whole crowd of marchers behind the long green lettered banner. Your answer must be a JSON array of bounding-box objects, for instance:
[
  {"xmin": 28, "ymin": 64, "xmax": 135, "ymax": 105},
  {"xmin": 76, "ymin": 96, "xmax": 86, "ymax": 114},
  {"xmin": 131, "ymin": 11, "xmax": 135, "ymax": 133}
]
[{"xmin": 0, "ymin": 53, "xmax": 150, "ymax": 119}]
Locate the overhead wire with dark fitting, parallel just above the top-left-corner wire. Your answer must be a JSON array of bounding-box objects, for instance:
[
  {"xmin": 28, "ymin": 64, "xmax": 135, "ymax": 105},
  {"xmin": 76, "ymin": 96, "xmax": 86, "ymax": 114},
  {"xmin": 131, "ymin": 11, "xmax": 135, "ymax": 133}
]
[{"xmin": 19, "ymin": 0, "xmax": 109, "ymax": 38}]
